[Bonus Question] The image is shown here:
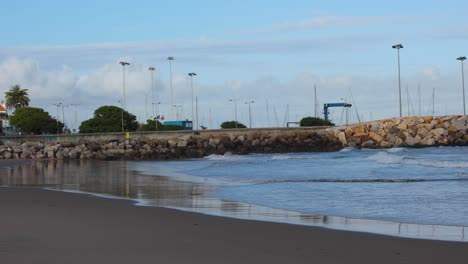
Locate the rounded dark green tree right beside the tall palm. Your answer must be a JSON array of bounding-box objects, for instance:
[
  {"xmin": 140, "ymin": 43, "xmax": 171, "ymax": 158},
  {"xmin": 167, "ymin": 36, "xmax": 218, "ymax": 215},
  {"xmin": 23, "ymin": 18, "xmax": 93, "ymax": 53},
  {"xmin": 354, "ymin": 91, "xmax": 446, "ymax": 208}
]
[{"xmin": 10, "ymin": 107, "xmax": 63, "ymax": 134}]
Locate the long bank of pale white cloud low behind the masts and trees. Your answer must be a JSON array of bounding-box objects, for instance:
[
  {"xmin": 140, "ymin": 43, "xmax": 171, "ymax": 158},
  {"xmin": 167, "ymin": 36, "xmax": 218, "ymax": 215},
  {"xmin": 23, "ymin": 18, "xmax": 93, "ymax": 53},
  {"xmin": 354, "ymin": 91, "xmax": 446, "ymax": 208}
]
[{"xmin": 0, "ymin": 58, "xmax": 461, "ymax": 130}]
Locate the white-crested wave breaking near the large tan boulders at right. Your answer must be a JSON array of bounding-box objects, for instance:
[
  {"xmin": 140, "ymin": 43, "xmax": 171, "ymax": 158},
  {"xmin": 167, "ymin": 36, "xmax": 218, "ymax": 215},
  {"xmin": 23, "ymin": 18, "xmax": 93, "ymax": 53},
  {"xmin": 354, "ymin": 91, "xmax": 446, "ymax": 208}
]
[{"xmin": 367, "ymin": 152, "xmax": 468, "ymax": 168}]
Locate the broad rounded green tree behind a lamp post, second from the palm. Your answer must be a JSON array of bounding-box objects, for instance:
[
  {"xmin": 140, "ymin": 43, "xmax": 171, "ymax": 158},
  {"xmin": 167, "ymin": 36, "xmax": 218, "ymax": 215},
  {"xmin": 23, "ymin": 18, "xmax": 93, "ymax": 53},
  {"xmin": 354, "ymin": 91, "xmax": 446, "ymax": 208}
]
[{"xmin": 80, "ymin": 105, "xmax": 138, "ymax": 133}]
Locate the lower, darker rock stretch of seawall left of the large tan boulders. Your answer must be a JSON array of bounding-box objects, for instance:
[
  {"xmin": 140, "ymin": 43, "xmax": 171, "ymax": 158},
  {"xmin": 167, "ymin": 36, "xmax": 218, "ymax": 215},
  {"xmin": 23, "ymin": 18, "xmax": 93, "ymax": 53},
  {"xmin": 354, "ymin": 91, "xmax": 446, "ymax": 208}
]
[{"xmin": 0, "ymin": 130, "xmax": 342, "ymax": 160}]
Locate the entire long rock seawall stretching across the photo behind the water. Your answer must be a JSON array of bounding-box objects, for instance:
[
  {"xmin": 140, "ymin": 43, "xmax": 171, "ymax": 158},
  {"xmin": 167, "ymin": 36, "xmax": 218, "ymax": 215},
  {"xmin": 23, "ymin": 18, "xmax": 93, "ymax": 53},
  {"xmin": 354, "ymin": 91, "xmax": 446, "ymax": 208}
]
[{"xmin": 0, "ymin": 116, "xmax": 468, "ymax": 160}]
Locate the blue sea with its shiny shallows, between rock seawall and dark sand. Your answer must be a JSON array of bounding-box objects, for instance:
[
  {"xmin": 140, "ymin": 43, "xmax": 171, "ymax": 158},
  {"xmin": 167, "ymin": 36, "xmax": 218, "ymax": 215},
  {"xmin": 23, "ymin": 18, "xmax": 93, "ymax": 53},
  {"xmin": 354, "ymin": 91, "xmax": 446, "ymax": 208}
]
[{"xmin": 0, "ymin": 147, "xmax": 468, "ymax": 241}]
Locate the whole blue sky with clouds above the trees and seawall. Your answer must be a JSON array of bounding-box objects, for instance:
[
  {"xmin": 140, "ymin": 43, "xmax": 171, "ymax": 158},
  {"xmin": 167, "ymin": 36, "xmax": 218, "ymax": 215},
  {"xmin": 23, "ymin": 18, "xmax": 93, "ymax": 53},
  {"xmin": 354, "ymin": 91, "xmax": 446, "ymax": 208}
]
[{"xmin": 0, "ymin": 0, "xmax": 468, "ymax": 128}]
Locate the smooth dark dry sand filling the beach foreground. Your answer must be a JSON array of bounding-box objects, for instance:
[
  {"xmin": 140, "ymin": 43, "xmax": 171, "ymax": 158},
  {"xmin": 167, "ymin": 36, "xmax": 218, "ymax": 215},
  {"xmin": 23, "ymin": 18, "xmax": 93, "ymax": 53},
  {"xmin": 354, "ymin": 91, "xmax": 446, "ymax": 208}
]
[{"xmin": 0, "ymin": 188, "xmax": 468, "ymax": 264}]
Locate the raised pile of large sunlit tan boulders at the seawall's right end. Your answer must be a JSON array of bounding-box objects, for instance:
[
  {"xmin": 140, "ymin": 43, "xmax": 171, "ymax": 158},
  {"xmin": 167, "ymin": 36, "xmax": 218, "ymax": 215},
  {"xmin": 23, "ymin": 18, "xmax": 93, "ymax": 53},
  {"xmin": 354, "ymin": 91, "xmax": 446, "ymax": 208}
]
[{"xmin": 327, "ymin": 116, "xmax": 468, "ymax": 148}]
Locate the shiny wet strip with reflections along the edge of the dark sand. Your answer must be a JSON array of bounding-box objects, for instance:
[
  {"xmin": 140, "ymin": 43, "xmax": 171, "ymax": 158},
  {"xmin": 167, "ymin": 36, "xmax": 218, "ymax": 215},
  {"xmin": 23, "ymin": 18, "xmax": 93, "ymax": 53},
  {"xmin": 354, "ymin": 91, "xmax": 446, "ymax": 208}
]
[{"xmin": 0, "ymin": 160, "xmax": 468, "ymax": 241}]
